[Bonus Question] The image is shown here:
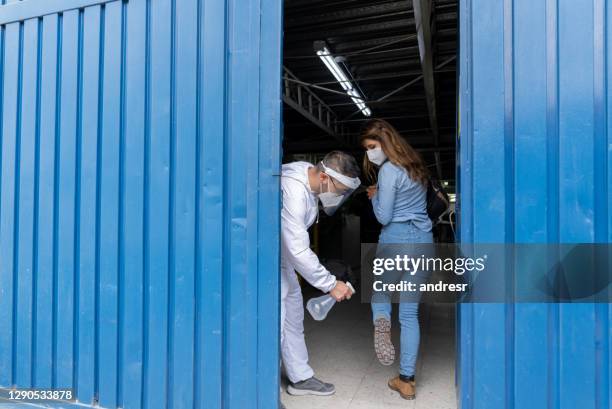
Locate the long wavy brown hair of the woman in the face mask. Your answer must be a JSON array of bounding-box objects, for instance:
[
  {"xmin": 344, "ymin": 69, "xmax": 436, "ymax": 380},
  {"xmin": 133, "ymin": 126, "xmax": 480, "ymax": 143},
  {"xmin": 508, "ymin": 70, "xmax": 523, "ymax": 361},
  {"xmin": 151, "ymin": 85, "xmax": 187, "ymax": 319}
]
[{"xmin": 360, "ymin": 119, "xmax": 430, "ymax": 186}]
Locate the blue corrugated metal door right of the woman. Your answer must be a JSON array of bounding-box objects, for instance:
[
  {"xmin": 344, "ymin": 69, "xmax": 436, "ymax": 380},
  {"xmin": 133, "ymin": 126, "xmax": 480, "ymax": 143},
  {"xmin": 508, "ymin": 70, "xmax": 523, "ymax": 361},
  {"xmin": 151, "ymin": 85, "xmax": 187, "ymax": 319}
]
[{"xmin": 458, "ymin": 0, "xmax": 612, "ymax": 409}]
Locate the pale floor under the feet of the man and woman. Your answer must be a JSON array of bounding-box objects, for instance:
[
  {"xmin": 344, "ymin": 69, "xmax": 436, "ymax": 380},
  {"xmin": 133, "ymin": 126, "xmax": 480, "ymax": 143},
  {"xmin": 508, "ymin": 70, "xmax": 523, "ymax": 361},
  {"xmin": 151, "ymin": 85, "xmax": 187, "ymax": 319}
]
[{"xmin": 281, "ymin": 295, "xmax": 457, "ymax": 409}]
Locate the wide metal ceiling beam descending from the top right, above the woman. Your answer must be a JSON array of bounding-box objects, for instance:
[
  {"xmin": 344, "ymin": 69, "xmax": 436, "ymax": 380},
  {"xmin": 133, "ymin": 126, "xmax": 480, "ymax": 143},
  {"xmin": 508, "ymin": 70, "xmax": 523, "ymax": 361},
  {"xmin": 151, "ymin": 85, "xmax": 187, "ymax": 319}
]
[{"xmin": 412, "ymin": 0, "xmax": 442, "ymax": 178}]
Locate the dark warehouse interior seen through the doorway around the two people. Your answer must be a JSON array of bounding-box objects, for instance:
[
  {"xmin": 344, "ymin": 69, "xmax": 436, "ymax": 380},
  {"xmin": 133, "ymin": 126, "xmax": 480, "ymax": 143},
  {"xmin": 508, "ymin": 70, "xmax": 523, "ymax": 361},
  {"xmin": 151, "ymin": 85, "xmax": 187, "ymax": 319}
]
[{"xmin": 281, "ymin": 0, "xmax": 458, "ymax": 409}]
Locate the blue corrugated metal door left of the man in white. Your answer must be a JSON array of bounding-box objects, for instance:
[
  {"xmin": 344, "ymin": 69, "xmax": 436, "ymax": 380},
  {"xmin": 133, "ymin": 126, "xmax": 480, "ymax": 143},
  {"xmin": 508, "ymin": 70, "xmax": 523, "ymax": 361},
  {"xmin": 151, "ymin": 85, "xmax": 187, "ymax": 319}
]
[{"xmin": 0, "ymin": 0, "xmax": 281, "ymax": 409}]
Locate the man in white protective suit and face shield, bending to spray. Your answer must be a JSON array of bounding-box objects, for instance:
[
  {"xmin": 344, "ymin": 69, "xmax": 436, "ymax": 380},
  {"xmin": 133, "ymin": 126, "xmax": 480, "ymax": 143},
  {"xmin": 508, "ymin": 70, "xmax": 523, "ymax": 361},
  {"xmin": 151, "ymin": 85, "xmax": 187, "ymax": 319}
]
[{"xmin": 281, "ymin": 151, "xmax": 361, "ymax": 396}]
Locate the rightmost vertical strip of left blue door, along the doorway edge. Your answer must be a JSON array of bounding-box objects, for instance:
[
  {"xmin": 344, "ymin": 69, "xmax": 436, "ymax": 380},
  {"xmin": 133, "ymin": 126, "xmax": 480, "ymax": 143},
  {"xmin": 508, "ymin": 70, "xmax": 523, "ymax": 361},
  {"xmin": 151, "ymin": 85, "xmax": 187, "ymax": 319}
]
[{"xmin": 254, "ymin": 0, "xmax": 283, "ymax": 408}]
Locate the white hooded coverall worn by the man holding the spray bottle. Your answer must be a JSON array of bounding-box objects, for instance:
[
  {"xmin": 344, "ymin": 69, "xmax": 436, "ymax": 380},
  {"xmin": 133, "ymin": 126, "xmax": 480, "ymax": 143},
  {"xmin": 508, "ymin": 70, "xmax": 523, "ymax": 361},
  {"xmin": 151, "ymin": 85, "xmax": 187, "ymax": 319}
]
[{"xmin": 281, "ymin": 162, "xmax": 336, "ymax": 383}]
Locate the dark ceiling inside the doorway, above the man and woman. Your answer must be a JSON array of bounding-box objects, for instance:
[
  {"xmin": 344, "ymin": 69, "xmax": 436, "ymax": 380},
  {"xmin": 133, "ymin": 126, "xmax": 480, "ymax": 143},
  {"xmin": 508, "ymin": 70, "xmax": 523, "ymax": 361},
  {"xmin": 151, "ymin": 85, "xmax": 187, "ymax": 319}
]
[{"xmin": 284, "ymin": 0, "xmax": 458, "ymax": 179}]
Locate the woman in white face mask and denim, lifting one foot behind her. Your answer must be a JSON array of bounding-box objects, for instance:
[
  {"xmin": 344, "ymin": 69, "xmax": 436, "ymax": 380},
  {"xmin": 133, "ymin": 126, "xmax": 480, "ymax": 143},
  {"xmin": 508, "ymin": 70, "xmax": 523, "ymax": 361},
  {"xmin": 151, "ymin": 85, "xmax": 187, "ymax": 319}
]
[{"xmin": 361, "ymin": 119, "xmax": 433, "ymax": 399}]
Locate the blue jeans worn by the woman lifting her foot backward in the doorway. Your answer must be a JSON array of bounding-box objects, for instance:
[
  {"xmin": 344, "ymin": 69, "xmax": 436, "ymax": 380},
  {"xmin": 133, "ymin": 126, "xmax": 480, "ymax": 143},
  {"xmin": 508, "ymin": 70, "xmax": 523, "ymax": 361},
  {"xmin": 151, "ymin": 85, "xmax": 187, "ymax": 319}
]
[{"xmin": 372, "ymin": 222, "xmax": 433, "ymax": 376}]
